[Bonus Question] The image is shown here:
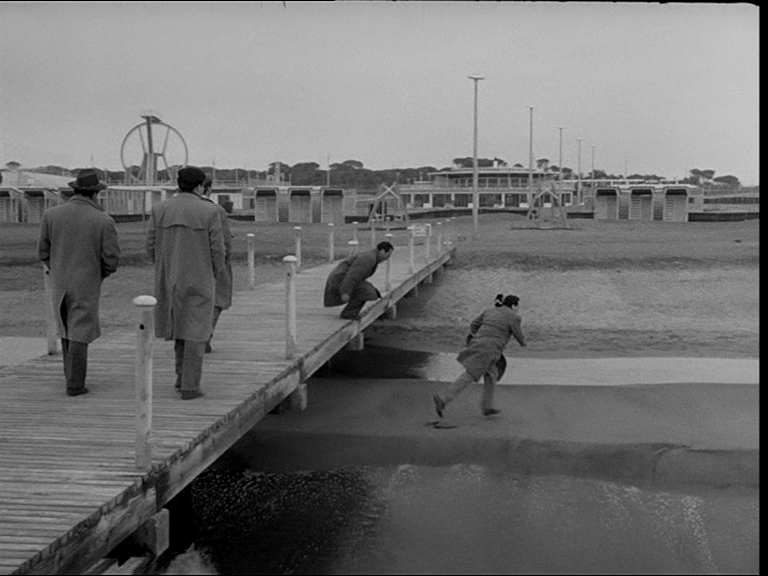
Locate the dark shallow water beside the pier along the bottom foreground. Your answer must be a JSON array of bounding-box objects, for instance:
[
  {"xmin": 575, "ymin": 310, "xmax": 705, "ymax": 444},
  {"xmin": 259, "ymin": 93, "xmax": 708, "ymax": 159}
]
[{"xmin": 147, "ymin": 465, "xmax": 759, "ymax": 574}]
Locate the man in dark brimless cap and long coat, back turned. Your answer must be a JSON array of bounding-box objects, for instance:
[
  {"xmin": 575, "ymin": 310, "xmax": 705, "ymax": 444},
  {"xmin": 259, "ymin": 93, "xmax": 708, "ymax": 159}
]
[{"xmin": 146, "ymin": 166, "xmax": 224, "ymax": 400}]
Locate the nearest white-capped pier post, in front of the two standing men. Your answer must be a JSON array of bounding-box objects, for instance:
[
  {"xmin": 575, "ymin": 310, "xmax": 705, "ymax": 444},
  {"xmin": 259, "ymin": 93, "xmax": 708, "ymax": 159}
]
[{"xmin": 133, "ymin": 296, "xmax": 157, "ymax": 470}]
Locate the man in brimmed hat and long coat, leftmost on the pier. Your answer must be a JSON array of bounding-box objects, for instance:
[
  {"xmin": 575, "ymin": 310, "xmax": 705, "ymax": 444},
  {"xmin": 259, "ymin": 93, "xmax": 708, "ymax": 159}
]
[{"xmin": 38, "ymin": 168, "xmax": 120, "ymax": 396}]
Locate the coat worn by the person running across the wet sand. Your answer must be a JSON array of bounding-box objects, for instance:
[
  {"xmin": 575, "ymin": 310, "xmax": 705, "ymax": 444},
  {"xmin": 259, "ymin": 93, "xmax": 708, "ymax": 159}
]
[{"xmin": 456, "ymin": 306, "xmax": 526, "ymax": 380}]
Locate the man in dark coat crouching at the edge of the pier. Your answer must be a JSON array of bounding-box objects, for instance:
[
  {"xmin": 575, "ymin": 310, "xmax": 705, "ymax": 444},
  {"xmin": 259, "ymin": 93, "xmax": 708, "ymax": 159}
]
[{"xmin": 323, "ymin": 242, "xmax": 395, "ymax": 320}]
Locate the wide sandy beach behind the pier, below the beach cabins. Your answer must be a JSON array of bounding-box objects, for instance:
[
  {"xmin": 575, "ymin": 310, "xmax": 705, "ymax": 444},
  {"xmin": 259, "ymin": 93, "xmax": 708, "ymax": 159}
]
[{"xmin": 0, "ymin": 214, "xmax": 760, "ymax": 357}]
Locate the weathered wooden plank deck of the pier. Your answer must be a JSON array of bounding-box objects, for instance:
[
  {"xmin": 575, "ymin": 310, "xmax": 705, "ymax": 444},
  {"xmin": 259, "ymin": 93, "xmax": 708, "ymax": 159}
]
[{"xmin": 0, "ymin": 241, "xmax": 455, "ymax": 574}]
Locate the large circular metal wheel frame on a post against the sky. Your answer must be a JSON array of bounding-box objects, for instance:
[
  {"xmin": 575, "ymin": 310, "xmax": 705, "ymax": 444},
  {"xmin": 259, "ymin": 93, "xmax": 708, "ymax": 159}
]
[{"xmin": 120, "ymin": 114, "xmax": 189, "ymax": 186}]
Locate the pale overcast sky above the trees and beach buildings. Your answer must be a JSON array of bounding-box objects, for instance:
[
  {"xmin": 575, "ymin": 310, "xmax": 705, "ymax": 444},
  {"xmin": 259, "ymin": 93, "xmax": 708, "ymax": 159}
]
[{"xmin": 0, "ymin": 1, "xmax": 760, "ymax": 184}]
